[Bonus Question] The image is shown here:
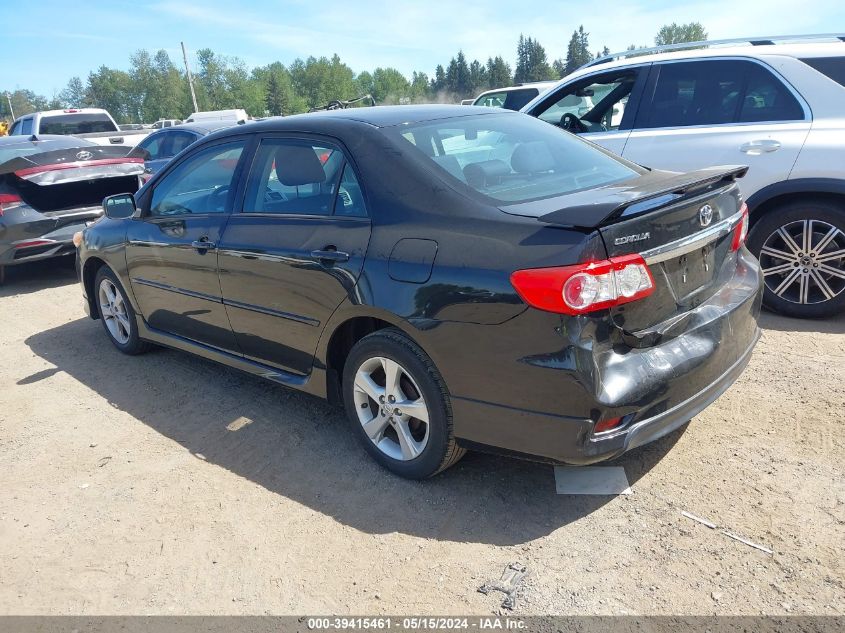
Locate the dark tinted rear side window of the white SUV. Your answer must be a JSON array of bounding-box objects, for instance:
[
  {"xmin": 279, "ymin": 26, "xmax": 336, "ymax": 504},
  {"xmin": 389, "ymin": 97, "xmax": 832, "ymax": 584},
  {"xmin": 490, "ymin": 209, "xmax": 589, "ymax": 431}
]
[{"xmin": 637, "ymin": 60, "xmax": 804, "ymax": 128}]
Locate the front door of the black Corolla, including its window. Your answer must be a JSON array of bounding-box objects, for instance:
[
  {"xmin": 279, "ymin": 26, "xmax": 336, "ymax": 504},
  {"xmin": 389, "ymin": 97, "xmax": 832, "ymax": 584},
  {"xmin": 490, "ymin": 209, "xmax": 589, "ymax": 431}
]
[{"xmin": 126, "ymin": 138, "xmax": 247, "ymax": 353}]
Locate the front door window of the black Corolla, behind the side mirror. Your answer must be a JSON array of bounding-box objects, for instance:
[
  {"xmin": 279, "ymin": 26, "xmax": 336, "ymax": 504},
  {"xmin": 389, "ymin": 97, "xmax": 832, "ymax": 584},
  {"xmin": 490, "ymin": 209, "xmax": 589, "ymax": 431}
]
[{"xmin": 150, "ymin": 141, "xmax": 246, "ymax": 217}]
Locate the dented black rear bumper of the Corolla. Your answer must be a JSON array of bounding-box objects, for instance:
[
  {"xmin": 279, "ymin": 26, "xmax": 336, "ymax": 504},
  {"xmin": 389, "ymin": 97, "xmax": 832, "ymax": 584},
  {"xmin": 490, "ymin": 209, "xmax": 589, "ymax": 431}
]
[{"xmin": 452, "ymin": 252, "xmax": 762, "ymax": 464}]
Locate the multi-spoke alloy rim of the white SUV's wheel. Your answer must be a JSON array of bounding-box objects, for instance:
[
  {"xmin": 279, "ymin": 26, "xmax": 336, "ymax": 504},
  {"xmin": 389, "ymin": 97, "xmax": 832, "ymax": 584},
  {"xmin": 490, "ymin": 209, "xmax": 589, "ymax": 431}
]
[{"xmin": 760, "ymin": 220, "xmax": 845, "ymax": 304}]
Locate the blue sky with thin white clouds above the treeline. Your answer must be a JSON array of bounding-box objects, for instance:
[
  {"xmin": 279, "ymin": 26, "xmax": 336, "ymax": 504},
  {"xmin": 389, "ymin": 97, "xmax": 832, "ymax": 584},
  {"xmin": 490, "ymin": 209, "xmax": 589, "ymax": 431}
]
[{"xmin": 0, "ymin": 0, "xmax": 845, "ymax": 97}]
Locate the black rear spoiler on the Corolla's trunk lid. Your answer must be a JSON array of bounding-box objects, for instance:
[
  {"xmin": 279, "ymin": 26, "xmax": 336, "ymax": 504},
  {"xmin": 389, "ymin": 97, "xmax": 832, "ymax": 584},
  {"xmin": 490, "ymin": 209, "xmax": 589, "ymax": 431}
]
[{"xmin": 538, "ymin": 165, "xmax": 748, "ymax": 229}]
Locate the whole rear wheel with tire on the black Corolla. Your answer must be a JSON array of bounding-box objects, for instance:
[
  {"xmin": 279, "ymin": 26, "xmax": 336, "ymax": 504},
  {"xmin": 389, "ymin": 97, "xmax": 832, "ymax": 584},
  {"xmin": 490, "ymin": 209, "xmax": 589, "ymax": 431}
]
[{"xmin": 343, "ymin": 328, "xmax": 466, "ymax": 479}]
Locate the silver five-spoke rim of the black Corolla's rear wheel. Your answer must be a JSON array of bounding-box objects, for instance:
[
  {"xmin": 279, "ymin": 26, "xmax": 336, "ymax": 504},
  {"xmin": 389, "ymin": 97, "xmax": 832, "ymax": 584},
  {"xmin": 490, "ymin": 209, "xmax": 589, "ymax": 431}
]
[{"xmin": 353, "ymin": 356, "xmax": 429, "ymax": 462}]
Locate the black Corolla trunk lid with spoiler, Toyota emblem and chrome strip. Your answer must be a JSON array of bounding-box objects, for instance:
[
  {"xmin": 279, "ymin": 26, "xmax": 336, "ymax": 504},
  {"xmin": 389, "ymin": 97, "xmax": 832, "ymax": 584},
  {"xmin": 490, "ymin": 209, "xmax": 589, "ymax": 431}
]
[{"xmin": 524, "ymin": 167, "xmax": 747, "ymax": 336}]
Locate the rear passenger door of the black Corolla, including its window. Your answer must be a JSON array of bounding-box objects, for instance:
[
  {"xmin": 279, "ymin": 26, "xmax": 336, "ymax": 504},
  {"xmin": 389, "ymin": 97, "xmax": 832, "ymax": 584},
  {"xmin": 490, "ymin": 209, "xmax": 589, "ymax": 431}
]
[{"xmin": 218, "ymin": 136, "xmax": 370, "ymax": 375}]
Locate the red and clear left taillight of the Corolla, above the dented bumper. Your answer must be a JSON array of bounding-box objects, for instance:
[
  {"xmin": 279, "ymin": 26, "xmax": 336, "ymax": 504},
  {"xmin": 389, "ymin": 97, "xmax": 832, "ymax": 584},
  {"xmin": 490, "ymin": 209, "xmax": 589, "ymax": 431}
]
[{"xmin": 511, "ymin": 254, "xmax": 654, "ymax": 314}]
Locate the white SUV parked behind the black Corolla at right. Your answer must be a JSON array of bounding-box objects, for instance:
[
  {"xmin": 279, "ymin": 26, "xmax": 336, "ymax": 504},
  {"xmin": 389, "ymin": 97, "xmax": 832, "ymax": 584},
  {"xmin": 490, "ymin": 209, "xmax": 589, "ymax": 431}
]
[{"xmin": 522, "ymin": 35, "xmax": 845, "ymax": 317}]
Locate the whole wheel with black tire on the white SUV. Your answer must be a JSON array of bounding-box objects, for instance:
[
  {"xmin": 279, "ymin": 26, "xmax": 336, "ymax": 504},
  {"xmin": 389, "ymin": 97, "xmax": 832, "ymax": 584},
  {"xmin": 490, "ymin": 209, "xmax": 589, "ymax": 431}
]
[{"xmin": 748, "ymin": 198, "xmax": 845, "ymax": 318}]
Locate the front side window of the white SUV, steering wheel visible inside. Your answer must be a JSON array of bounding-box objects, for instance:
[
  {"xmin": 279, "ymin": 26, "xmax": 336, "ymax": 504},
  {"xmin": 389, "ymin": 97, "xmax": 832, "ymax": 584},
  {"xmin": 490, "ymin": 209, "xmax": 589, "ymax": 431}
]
[{"xmin": 535, "ymin": 70, "xmax": 637, "ymax": 132}]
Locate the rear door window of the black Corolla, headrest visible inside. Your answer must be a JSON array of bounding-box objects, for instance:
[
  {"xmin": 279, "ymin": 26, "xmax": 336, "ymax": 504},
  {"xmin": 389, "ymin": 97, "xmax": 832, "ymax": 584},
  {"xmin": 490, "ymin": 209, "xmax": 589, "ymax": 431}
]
[{"xmin": 244, "ymin": 139, "xmax": 344, "ymax": 215}]
